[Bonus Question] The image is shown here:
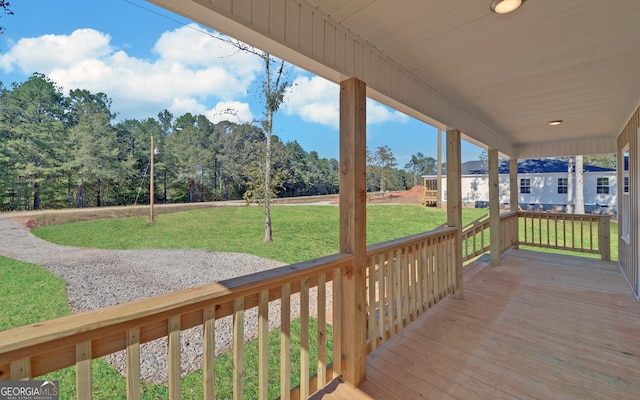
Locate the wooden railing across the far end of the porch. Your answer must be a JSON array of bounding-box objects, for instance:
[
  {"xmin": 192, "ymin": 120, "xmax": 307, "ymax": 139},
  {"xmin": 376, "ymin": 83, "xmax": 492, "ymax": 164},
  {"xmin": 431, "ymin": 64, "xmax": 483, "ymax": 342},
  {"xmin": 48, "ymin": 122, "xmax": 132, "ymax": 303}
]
[{"xmin": 518, "ymin": 211, "xmax": 611, "ymax": 260}]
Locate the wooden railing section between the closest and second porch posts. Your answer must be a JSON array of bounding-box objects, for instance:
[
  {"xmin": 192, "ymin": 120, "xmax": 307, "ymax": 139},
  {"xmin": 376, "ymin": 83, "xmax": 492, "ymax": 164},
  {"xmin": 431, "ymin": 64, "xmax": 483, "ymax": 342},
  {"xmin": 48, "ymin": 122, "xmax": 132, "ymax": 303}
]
[{"xmin": 367, "ymin": 228, "xmax": 457, "ymax": 352}]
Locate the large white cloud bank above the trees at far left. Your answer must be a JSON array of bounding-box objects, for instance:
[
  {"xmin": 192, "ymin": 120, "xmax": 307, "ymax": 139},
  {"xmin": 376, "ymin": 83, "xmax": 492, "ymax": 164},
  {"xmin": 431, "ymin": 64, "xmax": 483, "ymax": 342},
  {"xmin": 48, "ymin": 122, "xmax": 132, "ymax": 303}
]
[{"xmin": 0, "ymin": 25, "xmax": 262, "ymax": 118}]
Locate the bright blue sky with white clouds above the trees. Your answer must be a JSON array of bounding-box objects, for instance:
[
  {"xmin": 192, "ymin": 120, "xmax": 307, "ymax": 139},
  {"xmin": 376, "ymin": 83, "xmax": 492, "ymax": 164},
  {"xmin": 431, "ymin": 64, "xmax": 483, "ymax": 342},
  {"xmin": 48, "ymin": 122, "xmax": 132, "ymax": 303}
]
[{"xmin": 0, "ymin": 0, "xmax": 481, "ymax": 167}]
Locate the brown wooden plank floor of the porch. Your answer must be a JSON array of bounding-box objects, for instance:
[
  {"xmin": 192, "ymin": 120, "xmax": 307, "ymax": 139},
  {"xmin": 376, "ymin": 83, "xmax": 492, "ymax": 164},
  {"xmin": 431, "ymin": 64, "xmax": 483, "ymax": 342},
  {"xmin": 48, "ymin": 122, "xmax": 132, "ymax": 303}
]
[{"xmin": 313, "ymin": 250, "xmax": 640, "ymax": 400}]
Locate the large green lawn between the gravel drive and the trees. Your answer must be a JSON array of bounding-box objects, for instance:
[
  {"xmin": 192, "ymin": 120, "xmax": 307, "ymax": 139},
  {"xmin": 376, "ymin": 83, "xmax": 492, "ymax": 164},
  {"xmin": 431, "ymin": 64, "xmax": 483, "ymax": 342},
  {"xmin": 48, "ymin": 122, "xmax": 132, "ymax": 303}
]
[{"xmin": 32, "ymin": 205, "xmax": 486, "ymax": 263}]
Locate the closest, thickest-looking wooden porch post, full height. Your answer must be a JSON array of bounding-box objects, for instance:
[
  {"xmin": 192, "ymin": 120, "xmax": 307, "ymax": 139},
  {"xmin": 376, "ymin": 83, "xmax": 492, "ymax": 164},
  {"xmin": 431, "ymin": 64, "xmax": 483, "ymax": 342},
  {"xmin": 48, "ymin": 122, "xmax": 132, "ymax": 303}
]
[{"xmin": 334, "ymin": 78, "xmax": 367, "ymax": 387}]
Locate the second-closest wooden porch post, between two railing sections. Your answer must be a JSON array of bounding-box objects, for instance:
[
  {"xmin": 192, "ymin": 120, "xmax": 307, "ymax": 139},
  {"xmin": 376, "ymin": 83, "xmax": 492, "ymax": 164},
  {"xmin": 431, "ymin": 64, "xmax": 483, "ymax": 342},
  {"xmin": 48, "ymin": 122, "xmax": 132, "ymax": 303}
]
[{"xmin": 447, "ymin": 130, "xmax": 464, "ymax": 299}]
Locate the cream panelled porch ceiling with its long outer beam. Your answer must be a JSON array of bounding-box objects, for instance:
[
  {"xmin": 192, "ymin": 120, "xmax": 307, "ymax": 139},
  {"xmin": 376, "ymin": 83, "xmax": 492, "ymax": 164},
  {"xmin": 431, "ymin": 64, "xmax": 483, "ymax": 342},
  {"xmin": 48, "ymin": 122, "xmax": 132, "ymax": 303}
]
[{"xmin": 150, "ymin": 0, "xmax": 640, "ymax": 158}]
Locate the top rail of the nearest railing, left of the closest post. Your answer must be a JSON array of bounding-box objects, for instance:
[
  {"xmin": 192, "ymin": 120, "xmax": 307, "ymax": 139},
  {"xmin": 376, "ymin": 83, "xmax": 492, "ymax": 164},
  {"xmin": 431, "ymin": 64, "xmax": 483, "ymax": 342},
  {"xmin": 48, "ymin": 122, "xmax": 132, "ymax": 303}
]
[{"xmin": 0, "ymin": 253, "xmax": 353, "ymax": 358}]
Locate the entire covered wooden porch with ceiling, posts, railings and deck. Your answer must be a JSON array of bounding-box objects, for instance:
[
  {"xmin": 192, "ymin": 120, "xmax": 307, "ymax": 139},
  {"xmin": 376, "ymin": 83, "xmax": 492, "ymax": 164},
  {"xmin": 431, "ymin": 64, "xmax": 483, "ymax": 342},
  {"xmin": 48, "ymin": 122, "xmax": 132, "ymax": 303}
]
[{"xmin": 0, "ymin": 0, "xmax": 640, "ymax": 400}]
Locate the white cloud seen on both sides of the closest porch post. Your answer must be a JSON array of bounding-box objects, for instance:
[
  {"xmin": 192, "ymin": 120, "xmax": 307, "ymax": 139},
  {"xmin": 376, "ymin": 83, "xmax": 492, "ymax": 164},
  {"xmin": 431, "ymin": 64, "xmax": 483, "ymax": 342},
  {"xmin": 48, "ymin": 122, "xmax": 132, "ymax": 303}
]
[{"xmin": 283, "ymin": 76, "xmax": 408, "ymax": 128}]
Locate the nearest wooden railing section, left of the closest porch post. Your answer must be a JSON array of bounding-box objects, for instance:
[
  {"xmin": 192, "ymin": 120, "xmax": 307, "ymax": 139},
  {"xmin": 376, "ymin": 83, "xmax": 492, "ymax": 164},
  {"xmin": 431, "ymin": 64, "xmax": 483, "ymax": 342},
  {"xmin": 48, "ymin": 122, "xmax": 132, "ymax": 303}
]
[{"xmin": 0, "ymin": 254, "xmax": 353, "ymax": 399}]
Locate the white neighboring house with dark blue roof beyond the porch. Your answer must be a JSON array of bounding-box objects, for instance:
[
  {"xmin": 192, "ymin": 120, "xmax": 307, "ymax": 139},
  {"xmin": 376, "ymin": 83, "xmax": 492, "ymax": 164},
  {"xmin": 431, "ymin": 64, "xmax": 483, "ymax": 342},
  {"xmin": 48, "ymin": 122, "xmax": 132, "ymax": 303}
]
[{"xmin": 423, "ymin": 158, "xmax": 618, "ymax": 214}]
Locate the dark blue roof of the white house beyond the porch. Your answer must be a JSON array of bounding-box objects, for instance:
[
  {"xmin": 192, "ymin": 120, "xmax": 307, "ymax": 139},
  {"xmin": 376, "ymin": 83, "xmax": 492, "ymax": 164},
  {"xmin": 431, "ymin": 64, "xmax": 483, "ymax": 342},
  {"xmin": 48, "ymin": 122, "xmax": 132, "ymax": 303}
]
[{"xmin": 424, "ymin": 158, "xmax": 616, "ymax": 177}]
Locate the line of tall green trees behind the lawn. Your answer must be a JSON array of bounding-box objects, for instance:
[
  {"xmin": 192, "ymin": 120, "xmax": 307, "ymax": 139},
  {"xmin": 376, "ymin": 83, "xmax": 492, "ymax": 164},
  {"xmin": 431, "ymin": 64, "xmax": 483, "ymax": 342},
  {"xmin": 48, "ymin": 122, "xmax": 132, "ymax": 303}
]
[{"xmin": 0, "ymin": 73, "xmax": 435, "ymax": 210}]
